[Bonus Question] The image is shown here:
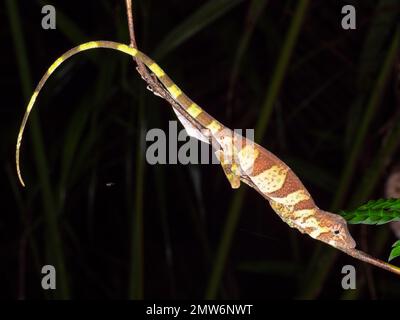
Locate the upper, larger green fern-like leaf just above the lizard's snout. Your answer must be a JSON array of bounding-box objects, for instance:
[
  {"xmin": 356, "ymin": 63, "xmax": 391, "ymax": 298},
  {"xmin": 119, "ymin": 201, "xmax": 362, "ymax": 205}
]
[{"xmin": 340, "ymin": 199, "xmax": 400, "ymax": 225}]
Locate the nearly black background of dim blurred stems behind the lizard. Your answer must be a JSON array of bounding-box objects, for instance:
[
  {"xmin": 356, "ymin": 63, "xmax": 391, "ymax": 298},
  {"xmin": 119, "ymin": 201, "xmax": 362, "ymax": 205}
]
[{"xmin": 0, "ymin": 0, "xmax": 400, "ymax": 299}]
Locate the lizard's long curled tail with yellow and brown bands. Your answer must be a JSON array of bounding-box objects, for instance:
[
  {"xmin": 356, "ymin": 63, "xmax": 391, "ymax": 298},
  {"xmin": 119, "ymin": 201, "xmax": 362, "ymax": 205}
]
[{"xmin": 15, "ymin": 41, "xmax": 222, "ymax": 186}]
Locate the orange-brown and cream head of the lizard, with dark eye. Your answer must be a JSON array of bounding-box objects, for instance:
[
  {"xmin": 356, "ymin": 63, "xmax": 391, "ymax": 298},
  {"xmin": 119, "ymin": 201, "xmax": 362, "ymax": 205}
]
[{"xmin": 316, "ymin": 210, "xmax": 356, "ymax": 249}]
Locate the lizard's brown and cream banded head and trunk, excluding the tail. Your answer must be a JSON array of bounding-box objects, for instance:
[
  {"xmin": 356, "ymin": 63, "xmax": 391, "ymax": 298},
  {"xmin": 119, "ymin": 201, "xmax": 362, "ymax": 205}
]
[{"xmin": 228, "ymin": 134, "xmax": 356, "ymax": 248}]
